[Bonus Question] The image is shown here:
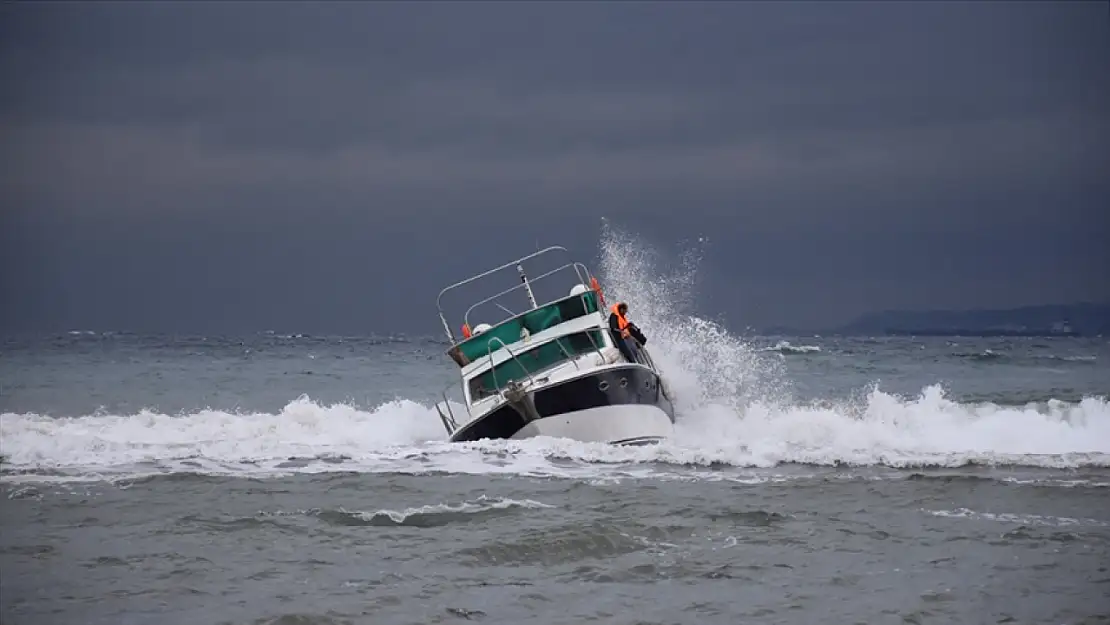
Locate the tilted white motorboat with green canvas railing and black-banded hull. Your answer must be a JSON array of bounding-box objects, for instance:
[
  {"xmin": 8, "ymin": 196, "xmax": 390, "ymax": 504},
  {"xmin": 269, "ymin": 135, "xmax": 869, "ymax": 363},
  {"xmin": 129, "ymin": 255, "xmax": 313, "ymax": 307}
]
[{"xmin": 435, "ymin": 245, "xmax": 675, "ymax": 445}]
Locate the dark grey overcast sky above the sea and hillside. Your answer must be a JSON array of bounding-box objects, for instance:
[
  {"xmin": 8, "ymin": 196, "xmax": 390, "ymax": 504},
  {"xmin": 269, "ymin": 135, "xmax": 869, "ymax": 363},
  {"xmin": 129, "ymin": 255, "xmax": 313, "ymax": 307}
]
[{"xmin": 0, "ymin": 1, "xmax": 1110, "ymax": 334}]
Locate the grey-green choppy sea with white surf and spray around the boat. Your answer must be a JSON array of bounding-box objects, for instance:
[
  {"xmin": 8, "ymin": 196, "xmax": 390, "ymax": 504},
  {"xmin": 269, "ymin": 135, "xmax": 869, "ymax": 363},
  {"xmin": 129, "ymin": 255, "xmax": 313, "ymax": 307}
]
[{"xmin": 0, "ymin": 230, "xmax": 1110, "ymax": 625}]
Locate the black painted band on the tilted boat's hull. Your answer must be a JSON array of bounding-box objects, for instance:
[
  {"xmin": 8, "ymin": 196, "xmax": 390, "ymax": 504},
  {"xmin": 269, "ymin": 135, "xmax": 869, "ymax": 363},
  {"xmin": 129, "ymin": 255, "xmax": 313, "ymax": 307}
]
[{"xmin": 451, "ymin": 365, "xmax": 675, "ymax": 442}]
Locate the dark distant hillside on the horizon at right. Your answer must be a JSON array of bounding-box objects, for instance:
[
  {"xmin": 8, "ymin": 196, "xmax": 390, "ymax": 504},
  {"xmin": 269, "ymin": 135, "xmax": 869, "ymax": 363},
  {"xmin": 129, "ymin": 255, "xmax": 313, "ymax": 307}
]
[{"xmin": 835, "ymin": 303, "xmax": 1110, "ymax": 336}]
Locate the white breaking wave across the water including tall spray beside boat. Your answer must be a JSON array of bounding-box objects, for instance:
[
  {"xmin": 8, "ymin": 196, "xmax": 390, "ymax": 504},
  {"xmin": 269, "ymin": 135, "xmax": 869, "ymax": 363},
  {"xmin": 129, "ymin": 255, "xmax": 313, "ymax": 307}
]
[{"xmin": 0, "ymin": 222, "xmax": 1110, "ymax": 481}]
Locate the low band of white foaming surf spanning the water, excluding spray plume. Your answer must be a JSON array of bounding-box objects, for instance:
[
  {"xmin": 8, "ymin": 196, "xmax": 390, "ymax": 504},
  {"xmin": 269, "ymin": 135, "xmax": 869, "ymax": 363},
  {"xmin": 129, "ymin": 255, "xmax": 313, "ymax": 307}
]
[{"xmin": 0, "ymin": 386, "xmax": 1110, "ymax": 482}]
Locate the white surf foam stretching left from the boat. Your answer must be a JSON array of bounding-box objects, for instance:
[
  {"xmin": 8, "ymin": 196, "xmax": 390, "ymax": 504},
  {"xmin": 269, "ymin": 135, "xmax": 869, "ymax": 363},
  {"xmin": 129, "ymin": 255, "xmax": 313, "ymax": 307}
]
[{"xmin": 0, "ymin": 396, "xmax": 443, "ymax": 479}]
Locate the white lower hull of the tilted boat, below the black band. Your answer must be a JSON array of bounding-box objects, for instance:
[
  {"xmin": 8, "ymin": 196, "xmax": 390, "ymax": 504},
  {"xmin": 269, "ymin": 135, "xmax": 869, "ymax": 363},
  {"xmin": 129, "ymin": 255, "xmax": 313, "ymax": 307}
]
[{"xmin": 512, "ymin": 404, "xmax": 674, "ymax": 444}]
